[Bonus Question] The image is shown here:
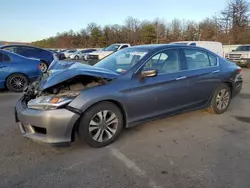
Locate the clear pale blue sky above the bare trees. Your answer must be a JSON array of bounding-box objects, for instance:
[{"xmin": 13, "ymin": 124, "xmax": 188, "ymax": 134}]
[{"xmin": 0, "ymin": 0, "xmax": 228, "ymax": 42}]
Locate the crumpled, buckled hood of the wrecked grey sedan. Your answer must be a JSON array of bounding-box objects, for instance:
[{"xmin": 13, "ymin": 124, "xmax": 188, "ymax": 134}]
[{"xmin": 40, "ymin": 61, "xmax": 119, "ymax": 90}]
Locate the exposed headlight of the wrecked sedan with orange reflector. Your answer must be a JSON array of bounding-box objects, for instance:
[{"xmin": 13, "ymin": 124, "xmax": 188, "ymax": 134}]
[{"xmin": 28, "ymin": 96, "xmax": 74, "ymax": 110}]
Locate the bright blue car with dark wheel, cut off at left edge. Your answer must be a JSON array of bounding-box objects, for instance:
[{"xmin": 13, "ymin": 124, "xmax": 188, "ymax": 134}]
[{"xmin": 0, "ymin": 49, "xmax": 41, "ymax": 92}]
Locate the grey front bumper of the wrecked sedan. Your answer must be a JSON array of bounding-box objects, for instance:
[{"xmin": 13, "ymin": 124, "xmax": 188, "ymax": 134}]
[{"xmin": 15, "ymin": 98, "xmax": 80, "ymax": 145}]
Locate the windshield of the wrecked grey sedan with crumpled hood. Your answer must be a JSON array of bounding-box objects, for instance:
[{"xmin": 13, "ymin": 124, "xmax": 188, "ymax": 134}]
[{"xmin": 94, "ymin": 48, "xmax": 148, "ymax": 74}]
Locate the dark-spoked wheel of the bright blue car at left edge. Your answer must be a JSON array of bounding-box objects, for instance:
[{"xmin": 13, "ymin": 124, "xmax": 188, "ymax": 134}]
[{"xmin": 6, "ymin": 74, "xmax": 29, "ymax": 92}]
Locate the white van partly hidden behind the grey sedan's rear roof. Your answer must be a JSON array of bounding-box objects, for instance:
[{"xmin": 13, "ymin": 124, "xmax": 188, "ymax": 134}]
[{"xmin": 170, "ymin": 41, "xmax": 224, "ymax": 57}]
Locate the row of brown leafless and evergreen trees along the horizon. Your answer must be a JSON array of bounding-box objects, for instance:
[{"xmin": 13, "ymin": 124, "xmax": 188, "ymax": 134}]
[{"xmin": 32, "ymin": 0, "xmax": 250, "ymax": 48}]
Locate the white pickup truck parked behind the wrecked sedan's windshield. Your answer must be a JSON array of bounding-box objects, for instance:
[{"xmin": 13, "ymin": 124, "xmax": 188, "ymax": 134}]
[{"xmin": 86, "ymin": 43, "xmax": 130, "ymax": 65}]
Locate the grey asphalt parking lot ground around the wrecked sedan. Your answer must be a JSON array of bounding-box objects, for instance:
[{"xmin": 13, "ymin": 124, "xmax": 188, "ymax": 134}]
[{"xmin": 0, "ymin": 69, "xmax": 250, "ymax": 188}]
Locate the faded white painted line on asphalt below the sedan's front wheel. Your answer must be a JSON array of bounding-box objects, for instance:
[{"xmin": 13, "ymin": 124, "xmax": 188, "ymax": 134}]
[{"xmin": 109, "ymin": 147, "xmax": 163, "ymax": 188}]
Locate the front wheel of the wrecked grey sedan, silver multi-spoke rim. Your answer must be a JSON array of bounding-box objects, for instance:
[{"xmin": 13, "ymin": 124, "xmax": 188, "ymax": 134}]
[{"xmin": 78, "ymin": 102, "xmax": 124, "ymax": 148}]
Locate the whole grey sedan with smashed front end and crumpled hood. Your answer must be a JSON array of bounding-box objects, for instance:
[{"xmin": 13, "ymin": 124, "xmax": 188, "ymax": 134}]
[{"xmin": 16, "ymin": 45, "xmax": 243, "ymax": 147}]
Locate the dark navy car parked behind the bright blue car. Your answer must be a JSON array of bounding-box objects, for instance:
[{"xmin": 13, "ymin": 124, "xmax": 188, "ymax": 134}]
[{"xmin": 0, "ymin": 44, "xmax": 57, "ymax": 72}]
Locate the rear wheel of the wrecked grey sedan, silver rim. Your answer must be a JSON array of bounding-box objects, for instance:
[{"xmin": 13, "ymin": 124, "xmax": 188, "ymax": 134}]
[{"xmin": 208, "ymin": 84, "xmax": 232, "ymax": 114}]
